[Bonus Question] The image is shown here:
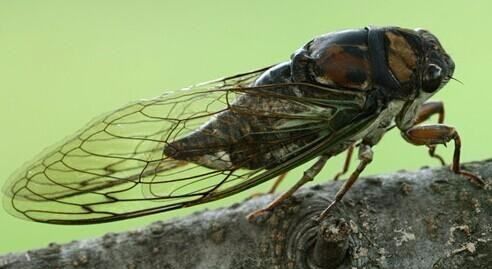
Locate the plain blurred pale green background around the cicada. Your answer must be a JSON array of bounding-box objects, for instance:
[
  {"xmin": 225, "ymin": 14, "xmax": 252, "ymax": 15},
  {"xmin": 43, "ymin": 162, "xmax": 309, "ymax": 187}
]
[{"xmin": 0, "ymin": 0, "xmax": 492, "ymax": 253}]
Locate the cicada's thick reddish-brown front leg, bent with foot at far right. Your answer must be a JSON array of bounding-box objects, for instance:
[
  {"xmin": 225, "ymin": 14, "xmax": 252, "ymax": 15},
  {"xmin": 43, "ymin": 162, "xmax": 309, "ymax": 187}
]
[{"xmin": 402, "ymin": 124, "xmax": 485, "ymax": 186}]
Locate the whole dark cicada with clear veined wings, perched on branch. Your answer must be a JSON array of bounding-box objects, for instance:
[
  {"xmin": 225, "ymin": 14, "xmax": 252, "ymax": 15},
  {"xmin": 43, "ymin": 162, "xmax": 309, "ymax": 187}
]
[{"xmin": 3, "ymin": 27, "xmax": 483, "ymax": 224}]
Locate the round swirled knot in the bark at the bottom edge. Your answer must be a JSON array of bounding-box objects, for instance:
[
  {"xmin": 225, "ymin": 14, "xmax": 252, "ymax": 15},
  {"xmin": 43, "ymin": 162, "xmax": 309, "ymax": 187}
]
[{"xmin": 266, "ymin": 194, "xmax": 353, "ymax": 269}]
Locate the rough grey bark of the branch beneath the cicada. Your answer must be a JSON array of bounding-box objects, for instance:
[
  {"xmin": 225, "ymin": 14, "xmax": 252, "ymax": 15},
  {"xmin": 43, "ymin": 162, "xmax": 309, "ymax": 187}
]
[{"xmin": 0, "ymin": 159, "xmax": 492, "ymax": 269}]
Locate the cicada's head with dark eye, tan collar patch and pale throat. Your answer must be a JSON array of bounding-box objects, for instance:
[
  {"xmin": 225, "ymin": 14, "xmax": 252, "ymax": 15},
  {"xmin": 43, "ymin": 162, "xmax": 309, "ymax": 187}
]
[{"xmin": 385, "ymin": 28, "xmax": 454, "ymax": 130}]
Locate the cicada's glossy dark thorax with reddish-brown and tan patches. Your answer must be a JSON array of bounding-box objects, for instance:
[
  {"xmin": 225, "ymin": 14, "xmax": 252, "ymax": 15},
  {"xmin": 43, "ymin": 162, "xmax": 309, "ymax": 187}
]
[{"xmin": 292, "ymin": 27, "xmax": 421, "ymax": 99}]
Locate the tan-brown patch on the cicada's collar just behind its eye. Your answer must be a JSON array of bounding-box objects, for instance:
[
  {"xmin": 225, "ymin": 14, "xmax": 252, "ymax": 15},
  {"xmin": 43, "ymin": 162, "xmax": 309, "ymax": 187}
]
[{"xmin": 386, "ymin": 32, "xmax": 417, "ymax": 82}]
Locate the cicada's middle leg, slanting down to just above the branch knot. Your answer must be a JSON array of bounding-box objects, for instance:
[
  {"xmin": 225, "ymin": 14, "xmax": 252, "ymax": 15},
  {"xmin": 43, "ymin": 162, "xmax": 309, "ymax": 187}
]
[{"xmin": 318, "ymin": 144, "xmax": 373, "ymax": 221}]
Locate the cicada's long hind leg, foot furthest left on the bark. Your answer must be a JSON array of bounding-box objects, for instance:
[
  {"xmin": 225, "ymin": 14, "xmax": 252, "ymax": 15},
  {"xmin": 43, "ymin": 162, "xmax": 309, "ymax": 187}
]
[{"xmin": 247, "ymin": 155, "xmax": 330, "ymax": 221}]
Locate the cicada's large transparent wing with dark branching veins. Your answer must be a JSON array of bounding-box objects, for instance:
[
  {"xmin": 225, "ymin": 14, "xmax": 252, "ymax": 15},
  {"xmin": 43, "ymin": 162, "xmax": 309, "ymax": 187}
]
[{"xmin": 3, "ymin": 67, "xmax": 371, "ymax": 224}]
